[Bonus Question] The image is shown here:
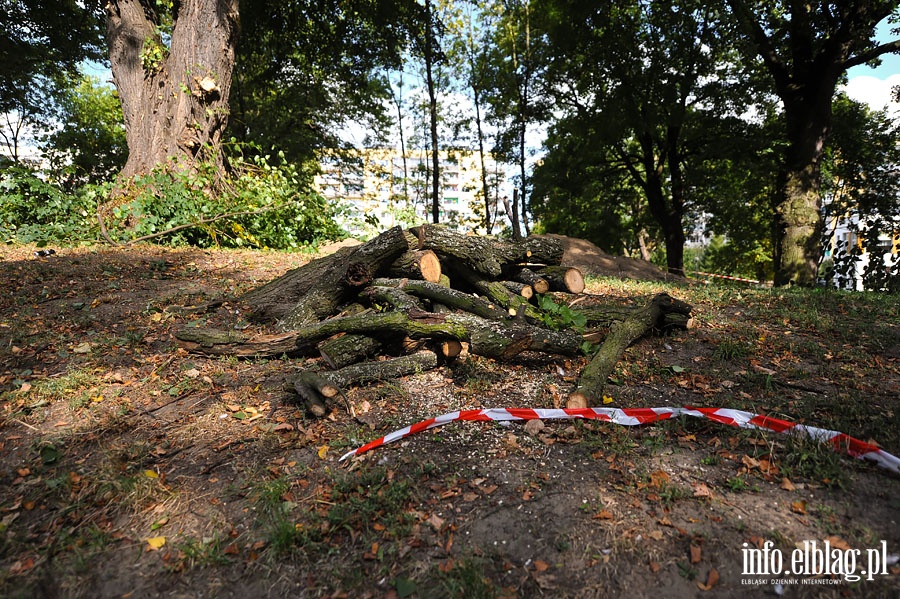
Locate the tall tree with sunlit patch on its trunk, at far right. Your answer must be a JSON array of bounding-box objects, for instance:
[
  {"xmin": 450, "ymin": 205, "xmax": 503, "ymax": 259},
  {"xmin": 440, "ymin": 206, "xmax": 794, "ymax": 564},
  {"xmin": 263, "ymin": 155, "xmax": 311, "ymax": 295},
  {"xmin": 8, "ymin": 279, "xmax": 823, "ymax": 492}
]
[{"xmin": 728, "ymin": 0, "xmax": 900, "ymax": 285}]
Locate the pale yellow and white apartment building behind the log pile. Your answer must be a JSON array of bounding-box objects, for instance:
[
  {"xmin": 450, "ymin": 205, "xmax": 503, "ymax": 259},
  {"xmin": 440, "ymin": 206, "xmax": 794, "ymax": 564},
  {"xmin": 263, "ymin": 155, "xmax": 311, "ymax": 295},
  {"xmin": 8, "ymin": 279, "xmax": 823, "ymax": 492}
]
[{"xmin": 315, "ymin": 148, "xmax": 506, "ymax": 235}]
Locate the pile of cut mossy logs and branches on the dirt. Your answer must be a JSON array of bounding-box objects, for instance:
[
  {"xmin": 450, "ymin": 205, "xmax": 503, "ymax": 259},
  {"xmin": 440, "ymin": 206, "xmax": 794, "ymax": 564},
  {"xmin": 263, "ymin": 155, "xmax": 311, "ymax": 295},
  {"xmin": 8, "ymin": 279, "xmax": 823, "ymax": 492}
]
[{"xmin": 176, "ymin": 225, "xmax": 691, "ymax": 416}]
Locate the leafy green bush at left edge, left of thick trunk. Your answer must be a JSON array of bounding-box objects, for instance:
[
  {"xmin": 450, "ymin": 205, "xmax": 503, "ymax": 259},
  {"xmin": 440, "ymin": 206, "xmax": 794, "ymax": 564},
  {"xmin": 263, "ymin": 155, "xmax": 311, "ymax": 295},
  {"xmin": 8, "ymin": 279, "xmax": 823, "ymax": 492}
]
[{"xmin": 0, "ymin": 167, "xmax": 96, "ymax": 246}]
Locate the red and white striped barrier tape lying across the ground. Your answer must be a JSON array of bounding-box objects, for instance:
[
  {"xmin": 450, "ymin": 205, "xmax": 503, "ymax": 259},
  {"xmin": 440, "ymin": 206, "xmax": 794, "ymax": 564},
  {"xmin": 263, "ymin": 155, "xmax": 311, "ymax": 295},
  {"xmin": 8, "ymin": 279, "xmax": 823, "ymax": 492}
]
[{"xmin": 341, "ymin": 407, "xmax": 900, "ymax": 474}]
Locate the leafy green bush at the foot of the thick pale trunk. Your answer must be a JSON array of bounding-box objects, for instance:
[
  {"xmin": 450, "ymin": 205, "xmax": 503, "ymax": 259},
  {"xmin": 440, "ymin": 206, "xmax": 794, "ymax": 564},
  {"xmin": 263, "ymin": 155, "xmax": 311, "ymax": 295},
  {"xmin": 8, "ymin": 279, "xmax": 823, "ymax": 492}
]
[{"xmin": 107, "ymin": 148, "xmax": 344, "ymax": 250}]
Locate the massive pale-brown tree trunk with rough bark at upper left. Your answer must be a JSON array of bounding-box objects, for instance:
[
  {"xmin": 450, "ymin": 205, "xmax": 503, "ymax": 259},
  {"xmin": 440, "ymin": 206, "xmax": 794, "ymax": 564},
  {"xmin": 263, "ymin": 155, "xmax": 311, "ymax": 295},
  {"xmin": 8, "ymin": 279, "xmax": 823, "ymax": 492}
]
[{"xmin": 107, "ymin": 0, "xmax": 238, "ymax": 178}]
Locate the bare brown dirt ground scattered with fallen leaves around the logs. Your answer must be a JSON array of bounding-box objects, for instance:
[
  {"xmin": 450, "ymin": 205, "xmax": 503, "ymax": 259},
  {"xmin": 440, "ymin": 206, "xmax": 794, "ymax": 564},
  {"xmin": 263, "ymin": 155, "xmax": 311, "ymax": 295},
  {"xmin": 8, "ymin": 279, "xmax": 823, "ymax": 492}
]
[{"xmin": 0, "ymin": 241, "xmax": 900, "ymax": 598}]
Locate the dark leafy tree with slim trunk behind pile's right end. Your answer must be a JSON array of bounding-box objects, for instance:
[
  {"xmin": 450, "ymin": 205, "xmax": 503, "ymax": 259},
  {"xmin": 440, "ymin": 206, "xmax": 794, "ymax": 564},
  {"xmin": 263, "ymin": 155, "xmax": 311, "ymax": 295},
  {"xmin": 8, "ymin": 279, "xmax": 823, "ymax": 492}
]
[{"xmin": 544, "ymin": 0, "xmax": 732, "ymax": 274}]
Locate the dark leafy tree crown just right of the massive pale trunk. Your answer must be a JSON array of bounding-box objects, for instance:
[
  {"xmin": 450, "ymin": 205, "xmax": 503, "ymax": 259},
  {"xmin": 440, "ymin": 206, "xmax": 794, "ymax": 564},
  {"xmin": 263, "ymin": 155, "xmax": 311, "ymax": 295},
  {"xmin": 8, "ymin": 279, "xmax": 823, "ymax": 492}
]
[{"xmin": 228, "ymin": 0, "xmax": 422, "ymax": 163}]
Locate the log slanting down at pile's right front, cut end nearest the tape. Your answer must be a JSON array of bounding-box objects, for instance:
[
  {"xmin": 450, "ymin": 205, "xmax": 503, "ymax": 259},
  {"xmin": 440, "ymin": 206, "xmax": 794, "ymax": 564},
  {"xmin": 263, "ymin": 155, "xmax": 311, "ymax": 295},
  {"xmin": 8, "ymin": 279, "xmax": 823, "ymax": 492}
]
[{"xmin": 567, "ymin": 293, "xmax": 691, "ymax": 408}]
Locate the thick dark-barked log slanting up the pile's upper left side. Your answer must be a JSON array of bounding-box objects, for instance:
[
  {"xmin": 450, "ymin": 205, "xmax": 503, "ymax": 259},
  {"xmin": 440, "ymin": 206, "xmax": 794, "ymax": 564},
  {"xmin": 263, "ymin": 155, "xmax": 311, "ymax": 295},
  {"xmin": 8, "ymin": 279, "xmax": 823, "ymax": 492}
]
[{"xmin": 241, "ymin": 227, "xmax": 409, "ymax": 330}]
